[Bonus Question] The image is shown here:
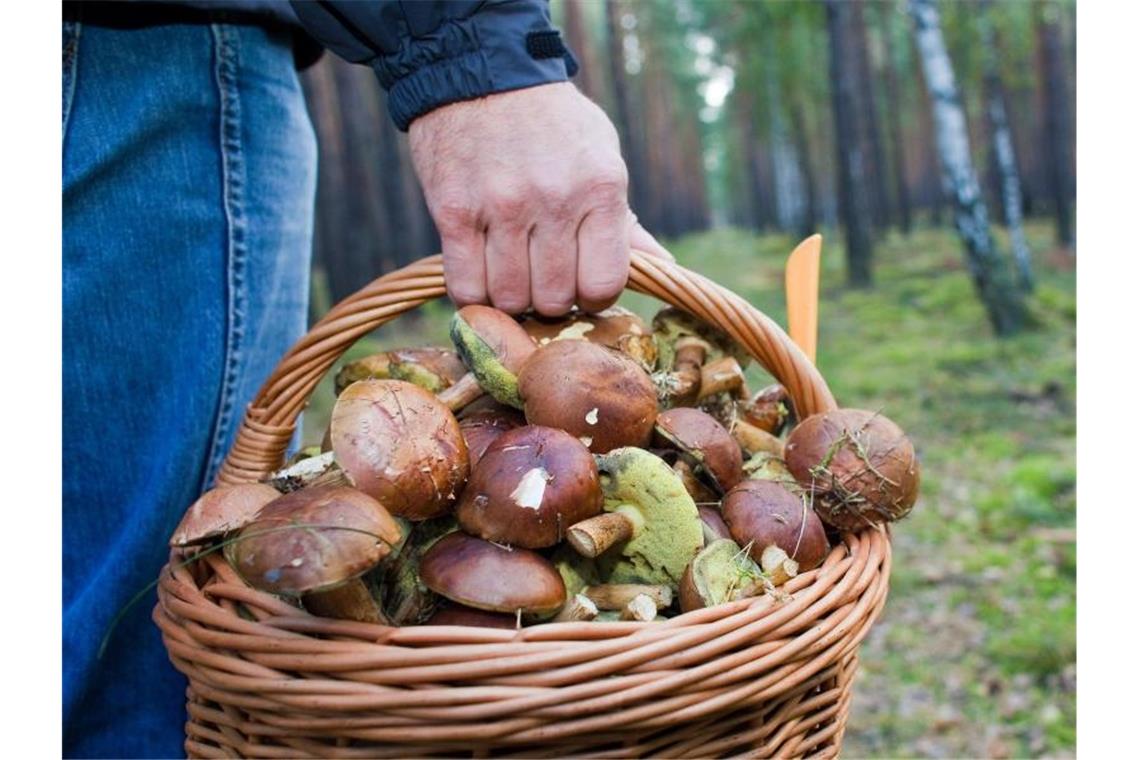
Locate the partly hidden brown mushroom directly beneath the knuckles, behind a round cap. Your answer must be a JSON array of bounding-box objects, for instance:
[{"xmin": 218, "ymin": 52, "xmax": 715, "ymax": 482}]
[{"xmin": 522, "ymin": 307, "xmax": 657, "ymax": 371}]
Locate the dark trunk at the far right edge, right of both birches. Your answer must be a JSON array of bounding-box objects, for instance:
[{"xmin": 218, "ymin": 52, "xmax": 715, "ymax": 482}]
[{"xmin": 1037, "ymin": 3, "xmax": 1075, "ymax": 247}]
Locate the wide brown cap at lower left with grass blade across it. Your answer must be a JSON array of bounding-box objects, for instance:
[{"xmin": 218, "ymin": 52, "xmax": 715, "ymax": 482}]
[{"xmin": 226, "ymin": 487, "xmax": 402, "ymax": 596}]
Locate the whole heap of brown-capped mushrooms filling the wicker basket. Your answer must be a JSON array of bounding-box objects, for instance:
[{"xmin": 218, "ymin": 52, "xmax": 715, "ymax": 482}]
[{"xmin": 171, "ymin": 305, "xmax": 919, "ymax": 629}]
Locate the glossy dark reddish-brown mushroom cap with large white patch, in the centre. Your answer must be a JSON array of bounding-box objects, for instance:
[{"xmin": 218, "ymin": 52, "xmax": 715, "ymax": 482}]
[{"xmin": 456, "ymin": 425, "xmax": 602, "ymax": 549}]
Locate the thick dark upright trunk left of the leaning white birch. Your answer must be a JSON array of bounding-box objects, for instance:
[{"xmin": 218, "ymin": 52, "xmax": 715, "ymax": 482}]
[{"xmin": 827, "ymin": 0, "xmax": 871, "ymax": 287}]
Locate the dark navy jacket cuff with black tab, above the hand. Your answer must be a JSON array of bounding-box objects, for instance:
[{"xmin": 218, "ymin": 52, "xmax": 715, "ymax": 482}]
[{"xmin": 369, "ymin": 2, "xmax": 578, "ymax": 131}]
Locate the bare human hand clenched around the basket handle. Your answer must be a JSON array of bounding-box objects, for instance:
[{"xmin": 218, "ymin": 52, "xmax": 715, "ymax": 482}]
[{"xmin": 408, "ymin": 82, "xmax": 671, "ymax": 316}]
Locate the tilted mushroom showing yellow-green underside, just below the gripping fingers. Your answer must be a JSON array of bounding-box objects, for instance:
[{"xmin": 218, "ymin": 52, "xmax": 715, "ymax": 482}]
[{"xmin": 440, "ymin": 304, "xmax": 536, "ymax": 409}]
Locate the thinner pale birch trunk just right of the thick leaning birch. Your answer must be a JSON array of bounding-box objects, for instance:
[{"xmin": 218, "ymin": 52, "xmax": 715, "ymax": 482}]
[{"xmin": 978, "ymin": 3, "xmax": 1033, "ymax": 293}]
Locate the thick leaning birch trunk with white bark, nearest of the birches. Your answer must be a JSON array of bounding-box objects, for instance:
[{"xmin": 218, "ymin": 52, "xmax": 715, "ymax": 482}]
[{"xmin": 910, "ymin": 0, "xmax": 1025, "ymax": 335}]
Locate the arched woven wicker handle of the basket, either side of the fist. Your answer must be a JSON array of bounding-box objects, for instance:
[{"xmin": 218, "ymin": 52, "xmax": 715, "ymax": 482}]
[{"xmin": 218, "ymin": 250, "xmax": 836, "ymax": 484}]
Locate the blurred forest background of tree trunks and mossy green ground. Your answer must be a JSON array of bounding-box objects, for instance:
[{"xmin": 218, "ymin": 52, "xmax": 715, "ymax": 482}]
[{"xmin": 304, "ymin": 0, "xmax": 1076, "ymax": 758}]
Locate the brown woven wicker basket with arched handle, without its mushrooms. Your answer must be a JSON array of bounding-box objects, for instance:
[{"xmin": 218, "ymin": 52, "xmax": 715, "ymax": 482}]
[{"xmin": 154, "ymin": 251, "xmax": 890, "ymax": 758}]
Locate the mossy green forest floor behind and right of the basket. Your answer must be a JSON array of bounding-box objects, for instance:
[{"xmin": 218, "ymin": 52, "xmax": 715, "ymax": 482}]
[{"xmin": 306, "ymin": 223, "xmax": 1076, "ymax": 758}]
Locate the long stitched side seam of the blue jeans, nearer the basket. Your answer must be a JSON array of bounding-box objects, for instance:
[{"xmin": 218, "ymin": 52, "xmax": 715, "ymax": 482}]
[{"xmin": 202, "ymin": 24, "xmax": 247, "ymax": 490}]
